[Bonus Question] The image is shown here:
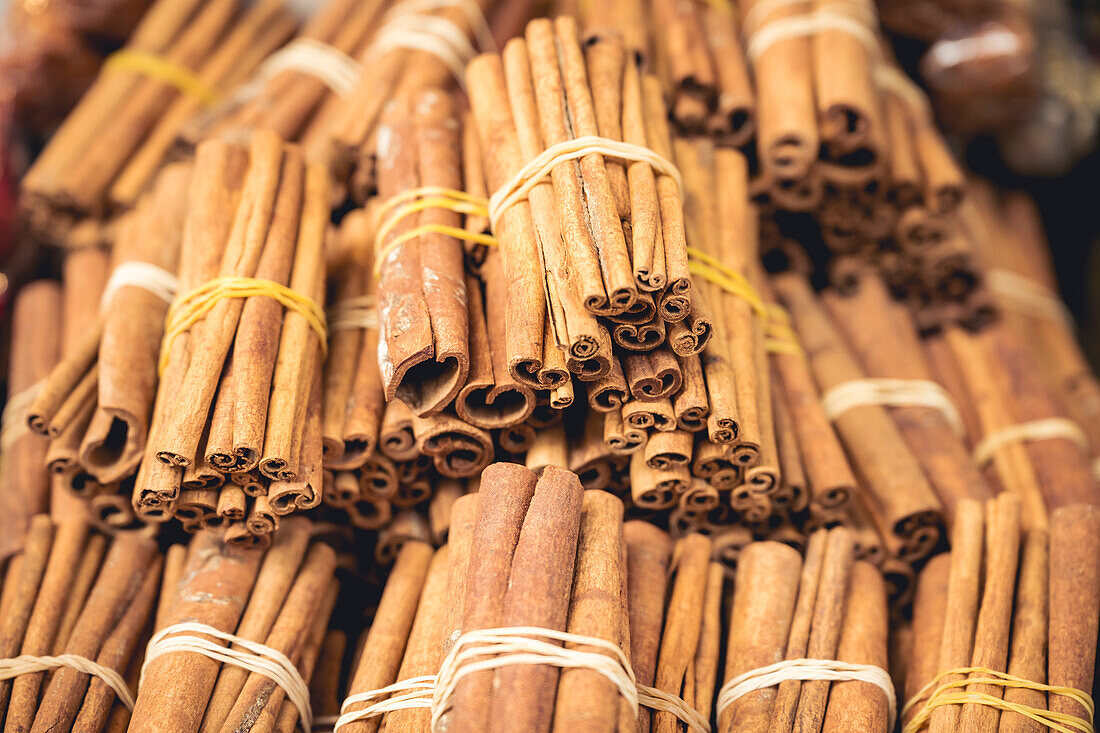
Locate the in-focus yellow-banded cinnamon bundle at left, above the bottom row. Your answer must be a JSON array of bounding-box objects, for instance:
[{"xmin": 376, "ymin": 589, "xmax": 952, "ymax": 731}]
[{"xmin": 125, "ymin": 132, "xmax": 328, "ymax": 544}]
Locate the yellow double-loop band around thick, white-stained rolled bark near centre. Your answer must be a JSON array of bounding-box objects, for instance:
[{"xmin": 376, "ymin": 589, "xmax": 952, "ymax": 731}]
[{"xmin": 374, "ymin": 186, "xmax": 496, "ymax": 275}]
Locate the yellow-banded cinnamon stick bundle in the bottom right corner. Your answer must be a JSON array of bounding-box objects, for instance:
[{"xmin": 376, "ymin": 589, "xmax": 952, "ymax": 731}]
[{"xmin": 903, "ymin": 493, "xmax": 1100, "ymax": 731}]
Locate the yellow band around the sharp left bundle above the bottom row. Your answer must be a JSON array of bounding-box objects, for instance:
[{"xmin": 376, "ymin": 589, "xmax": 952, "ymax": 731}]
[{"xmin": 158, "ymin": 277, "xmax": 328, "ymax": 374}]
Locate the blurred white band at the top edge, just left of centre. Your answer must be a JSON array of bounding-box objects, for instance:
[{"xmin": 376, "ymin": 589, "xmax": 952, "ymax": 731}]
[{"xmin": 364, "ymin": 0, "xmax": 496, "ymax": 85}]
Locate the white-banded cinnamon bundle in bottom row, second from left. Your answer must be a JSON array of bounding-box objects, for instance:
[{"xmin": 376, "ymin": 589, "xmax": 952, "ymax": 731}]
[{"xmin": 128, "ymin": 517, "xmax": 339, "ymax": 733}]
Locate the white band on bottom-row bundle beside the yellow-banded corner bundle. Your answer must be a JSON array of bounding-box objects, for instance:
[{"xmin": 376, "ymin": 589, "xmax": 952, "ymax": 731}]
[{"xmin": 717, "ymin": 659, "xmax": 898, "ymax": 731}]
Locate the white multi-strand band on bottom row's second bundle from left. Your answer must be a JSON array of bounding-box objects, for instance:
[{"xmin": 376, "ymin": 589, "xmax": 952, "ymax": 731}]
[{"xmin": 144, "ymin": 622, "xmax": 314, "ymax": 733}]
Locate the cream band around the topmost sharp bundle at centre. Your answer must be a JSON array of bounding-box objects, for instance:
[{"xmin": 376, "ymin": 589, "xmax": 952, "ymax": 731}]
[{"xmin": 488, "ymin": 135, "xmax": 683, "ymax": 230}]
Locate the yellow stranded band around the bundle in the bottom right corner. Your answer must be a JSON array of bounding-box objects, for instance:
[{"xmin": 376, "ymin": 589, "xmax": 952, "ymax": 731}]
[{"xmin": 901, "ymin": 667, "xmax": 1096, "ymax": 733}]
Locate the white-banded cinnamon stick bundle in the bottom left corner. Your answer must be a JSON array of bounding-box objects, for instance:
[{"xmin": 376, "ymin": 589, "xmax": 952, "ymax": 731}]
[{"xmin": 0, "ymin": 514, "xmax": 160, "ymax": 732}]
